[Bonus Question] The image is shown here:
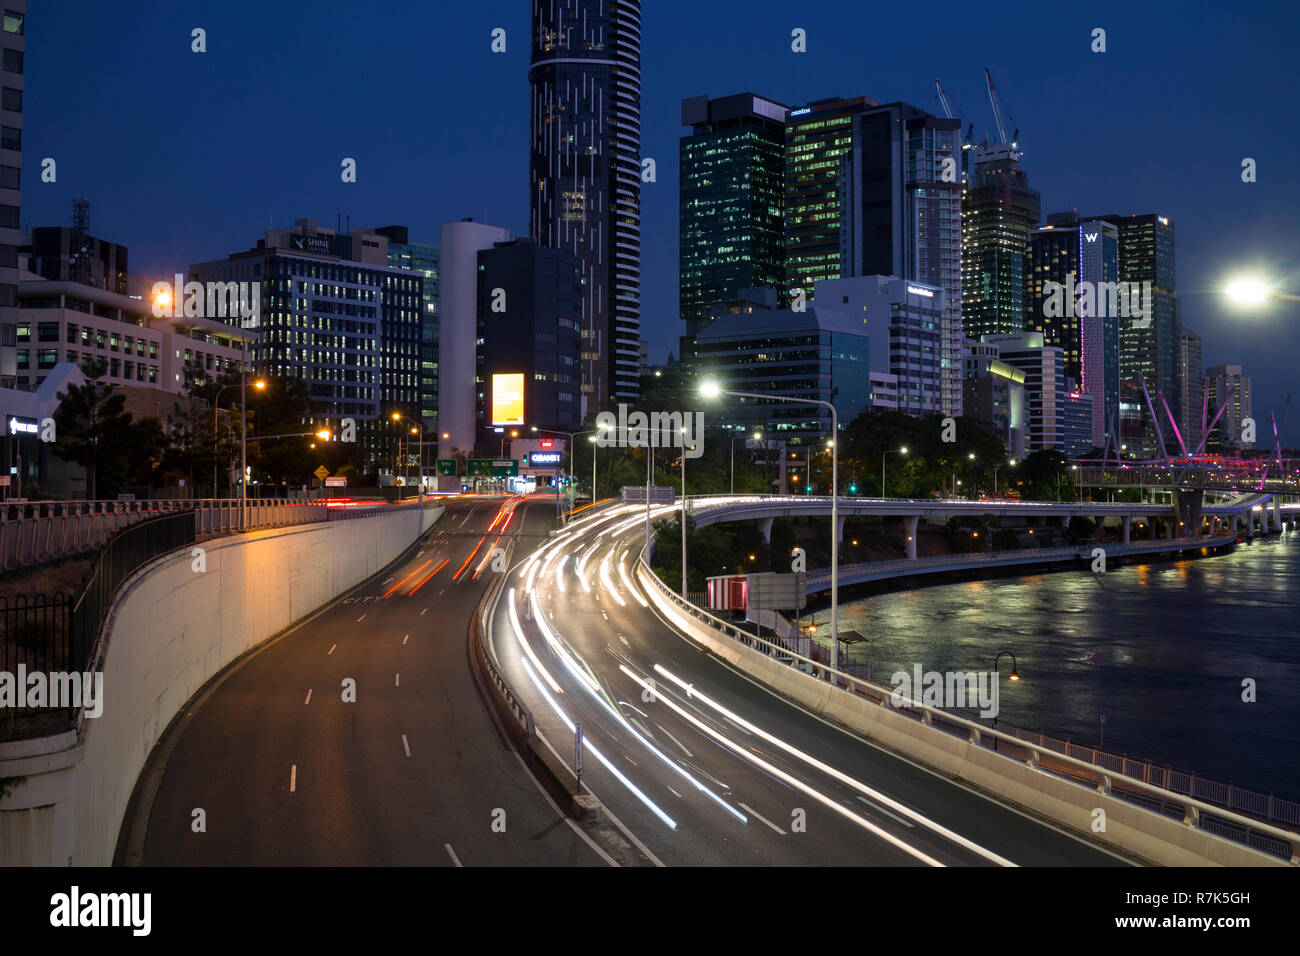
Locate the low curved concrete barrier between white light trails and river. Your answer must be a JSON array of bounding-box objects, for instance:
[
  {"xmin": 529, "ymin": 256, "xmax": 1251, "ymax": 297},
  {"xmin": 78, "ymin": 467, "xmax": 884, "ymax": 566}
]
[{"xmin": 638, "ymin": 566, "xmax": 1286, "ymax": 866}]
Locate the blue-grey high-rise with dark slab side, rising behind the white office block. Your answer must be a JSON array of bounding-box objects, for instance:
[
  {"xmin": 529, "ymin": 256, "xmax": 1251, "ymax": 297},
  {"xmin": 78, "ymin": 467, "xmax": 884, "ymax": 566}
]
[{"xmin": 842, "ymin": 103, "xmax": 963, "ymax": 415}]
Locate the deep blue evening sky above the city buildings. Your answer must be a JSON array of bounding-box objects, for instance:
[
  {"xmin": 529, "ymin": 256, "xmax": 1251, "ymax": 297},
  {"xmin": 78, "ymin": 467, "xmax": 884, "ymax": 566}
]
[{"xmin": 30, "ymin": 0, "xmax": 1300, "ymax": 445}]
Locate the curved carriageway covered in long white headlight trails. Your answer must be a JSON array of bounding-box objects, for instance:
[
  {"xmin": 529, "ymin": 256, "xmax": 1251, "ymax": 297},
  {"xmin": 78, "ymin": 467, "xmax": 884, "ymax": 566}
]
[{"xmin": 490, "ymin": 506, "xmax": 1126, "ymax": 866}]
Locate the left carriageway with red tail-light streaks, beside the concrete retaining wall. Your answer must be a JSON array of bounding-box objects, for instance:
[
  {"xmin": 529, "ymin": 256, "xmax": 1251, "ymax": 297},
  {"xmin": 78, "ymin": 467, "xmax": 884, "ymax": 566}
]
[{"xmin": 138, "ymin": 498, "xmax": 613, "ymax": 866}]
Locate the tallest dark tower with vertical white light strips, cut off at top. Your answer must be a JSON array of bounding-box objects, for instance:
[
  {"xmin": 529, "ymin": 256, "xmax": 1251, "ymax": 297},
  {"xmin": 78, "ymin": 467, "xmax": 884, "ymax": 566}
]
[{"xmin": 528, "ymin": 0, "xmax": 641, "ymax": 415}]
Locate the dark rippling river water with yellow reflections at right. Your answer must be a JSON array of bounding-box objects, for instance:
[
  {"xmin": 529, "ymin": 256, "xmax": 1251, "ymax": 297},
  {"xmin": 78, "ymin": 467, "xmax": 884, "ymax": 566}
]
[{"xmin": 818, "ymin": 532, "xmax": 1300, "ymax": 800}]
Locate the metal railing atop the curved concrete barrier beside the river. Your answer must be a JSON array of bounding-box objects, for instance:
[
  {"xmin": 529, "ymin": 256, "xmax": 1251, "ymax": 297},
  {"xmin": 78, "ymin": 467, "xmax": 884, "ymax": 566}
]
[{"xmin": 637, "ymin": 535, "xmax": 1300, "ymax": 864}]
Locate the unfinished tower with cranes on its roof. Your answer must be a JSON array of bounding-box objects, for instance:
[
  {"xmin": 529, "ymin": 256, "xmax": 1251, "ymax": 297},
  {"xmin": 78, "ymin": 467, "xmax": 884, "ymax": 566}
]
[{"xmin": 962, "ymin": 143, "xmax": 1041, "ymax": 338}]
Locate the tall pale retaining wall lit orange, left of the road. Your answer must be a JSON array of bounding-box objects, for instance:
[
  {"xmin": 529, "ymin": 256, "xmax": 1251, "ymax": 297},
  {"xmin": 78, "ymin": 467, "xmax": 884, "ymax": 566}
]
[{"xmin": 0, "ymin": 507, "xmax": 443, "ymax": 866}]
